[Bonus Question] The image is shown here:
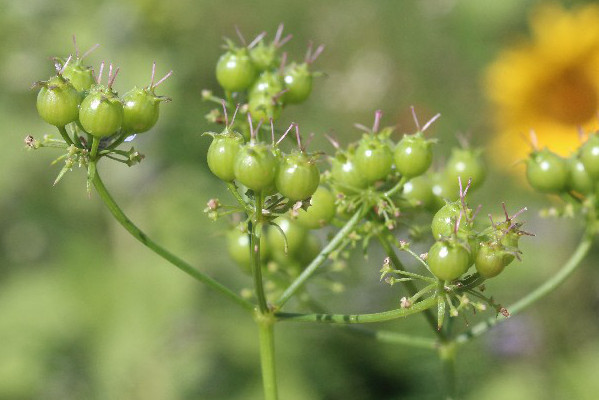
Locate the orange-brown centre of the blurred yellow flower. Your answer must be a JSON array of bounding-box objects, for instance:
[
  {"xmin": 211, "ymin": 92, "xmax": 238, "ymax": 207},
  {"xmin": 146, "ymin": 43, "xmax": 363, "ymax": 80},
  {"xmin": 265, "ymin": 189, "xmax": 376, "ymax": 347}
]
[{"xmin": 539, "ymin": 69, "xmax": 599, "ymax": 125}]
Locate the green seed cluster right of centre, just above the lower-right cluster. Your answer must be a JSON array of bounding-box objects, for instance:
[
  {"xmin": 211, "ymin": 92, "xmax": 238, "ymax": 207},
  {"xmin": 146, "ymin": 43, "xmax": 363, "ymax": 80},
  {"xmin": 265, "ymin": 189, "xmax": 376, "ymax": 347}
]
[{"xmin": 330, "ymin": 112, "xmax": 486, "ymax": 211}]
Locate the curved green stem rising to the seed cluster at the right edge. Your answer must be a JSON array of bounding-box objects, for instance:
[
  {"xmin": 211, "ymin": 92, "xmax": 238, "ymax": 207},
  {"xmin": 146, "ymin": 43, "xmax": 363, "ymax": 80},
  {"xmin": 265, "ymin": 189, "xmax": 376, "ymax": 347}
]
[{"xmin": 455, "ymin": 228, "xmax": 593, "ymax": 344}]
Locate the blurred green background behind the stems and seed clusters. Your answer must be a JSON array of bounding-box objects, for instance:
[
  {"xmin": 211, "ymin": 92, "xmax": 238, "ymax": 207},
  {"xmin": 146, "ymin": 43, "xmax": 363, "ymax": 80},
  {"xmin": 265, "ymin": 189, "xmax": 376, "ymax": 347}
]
[{"xmin": 0, "ymin": 0, "xmax": 599, "ymax": 400}]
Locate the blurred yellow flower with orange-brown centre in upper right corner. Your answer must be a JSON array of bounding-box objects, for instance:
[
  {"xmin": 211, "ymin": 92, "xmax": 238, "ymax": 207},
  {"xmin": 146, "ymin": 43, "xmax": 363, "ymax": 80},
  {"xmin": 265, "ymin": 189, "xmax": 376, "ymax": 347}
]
[{"xmin": 485, "ymin": 5, "xmax": 599, "ymax": 165}]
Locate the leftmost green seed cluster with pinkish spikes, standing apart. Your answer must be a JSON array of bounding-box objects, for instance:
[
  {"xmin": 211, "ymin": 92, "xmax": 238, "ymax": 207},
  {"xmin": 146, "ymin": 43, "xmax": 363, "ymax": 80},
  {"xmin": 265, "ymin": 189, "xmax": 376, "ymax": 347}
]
[{"xmin": 30, "ymin": 37, "xmax": 172, "ymax": 188}]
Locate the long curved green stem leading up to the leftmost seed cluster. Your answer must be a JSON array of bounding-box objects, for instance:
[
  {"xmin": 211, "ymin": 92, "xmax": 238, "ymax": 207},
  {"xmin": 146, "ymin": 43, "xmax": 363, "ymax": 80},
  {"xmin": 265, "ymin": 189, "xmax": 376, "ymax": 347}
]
[{"xmin": 93, "ymin": 172, "xmax": 254, "ymax": 311}]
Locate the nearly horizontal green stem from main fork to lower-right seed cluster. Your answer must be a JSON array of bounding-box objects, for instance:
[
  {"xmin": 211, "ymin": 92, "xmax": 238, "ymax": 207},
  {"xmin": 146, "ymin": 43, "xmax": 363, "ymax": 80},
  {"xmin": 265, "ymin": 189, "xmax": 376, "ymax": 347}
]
[{"xmin": 275, "ymin": 296, "xmax": 437, "ymax": 324}]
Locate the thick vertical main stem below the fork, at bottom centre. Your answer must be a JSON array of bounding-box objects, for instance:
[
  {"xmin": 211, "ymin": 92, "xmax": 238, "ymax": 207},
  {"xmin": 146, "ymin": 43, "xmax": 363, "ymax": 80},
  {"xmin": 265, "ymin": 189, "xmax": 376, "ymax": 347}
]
[{"xmin": 256, "ymin": 316, "xmax": 279, "ymax": 400}]
